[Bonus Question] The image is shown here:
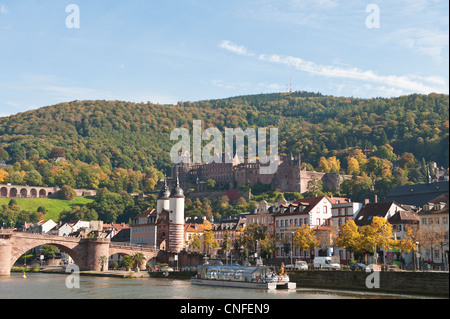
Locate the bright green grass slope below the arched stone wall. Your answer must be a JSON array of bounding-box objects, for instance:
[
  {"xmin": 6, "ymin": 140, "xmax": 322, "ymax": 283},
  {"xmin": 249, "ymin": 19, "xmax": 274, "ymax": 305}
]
[{"xmin": 0, "ymin": 197, "xmax": 94, "ymax": 221}]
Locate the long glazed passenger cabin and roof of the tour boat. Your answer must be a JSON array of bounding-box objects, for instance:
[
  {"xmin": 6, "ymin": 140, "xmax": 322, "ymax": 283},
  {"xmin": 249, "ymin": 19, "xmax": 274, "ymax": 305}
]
[{"xmin": 198, "ymin": 265, "xmax": 271, "ymax": 281}]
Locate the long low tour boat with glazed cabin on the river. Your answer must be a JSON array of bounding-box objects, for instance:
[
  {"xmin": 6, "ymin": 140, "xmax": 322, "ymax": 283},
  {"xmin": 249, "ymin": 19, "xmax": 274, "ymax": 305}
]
[{"xmin": 191, "ymin": 265, "xmax": 297, "ymax": 289}]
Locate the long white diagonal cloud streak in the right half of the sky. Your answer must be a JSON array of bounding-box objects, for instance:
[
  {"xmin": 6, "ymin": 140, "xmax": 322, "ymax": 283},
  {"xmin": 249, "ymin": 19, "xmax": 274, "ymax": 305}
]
[{"xmin": 222, "ymin": 40, "xmax": 448, "ymax": 94}]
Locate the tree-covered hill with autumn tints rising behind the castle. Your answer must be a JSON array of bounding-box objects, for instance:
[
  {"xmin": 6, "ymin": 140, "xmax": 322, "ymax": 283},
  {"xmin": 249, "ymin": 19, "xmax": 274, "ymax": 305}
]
[{"xmin": 0, "ymin": 92, "xmax": 449, "ymax": 195}]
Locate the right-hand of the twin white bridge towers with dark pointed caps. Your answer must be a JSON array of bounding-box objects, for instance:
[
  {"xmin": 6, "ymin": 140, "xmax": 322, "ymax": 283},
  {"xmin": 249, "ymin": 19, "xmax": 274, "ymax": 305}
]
[{"xmin": 167, "ymin": 174, "xmax": 185, "ymax": 252}]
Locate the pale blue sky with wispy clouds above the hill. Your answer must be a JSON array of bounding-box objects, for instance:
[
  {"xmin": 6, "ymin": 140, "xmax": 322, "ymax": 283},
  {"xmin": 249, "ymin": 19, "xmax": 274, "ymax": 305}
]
[{"xmin": 0, "ymin": 0, "xmax": 449, "ymax": 117}]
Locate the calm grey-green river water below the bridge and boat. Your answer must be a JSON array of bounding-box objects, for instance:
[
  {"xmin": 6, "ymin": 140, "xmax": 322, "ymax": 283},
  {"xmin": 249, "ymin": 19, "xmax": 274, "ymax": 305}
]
[{"xmin": 0, "ymin": 273, "xmax": 436, "ymax": 300}]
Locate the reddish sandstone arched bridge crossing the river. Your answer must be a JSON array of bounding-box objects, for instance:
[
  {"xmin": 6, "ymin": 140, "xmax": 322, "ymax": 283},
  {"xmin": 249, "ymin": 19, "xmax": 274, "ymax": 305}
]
[{"xmin": 0, "ymin": 229, "xmax": 159, "ymax": 276}]
